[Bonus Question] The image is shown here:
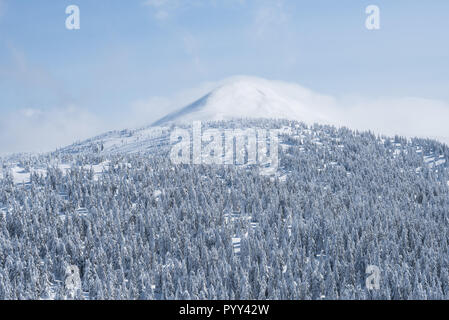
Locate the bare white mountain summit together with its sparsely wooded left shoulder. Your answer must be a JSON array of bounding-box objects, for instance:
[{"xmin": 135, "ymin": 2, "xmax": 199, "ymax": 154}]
[{"xmin": 51, "ymin": 77, "xmax": 333, "ymax": 154}]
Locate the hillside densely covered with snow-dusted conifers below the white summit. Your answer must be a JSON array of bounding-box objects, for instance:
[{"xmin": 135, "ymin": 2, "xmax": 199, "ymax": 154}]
[{"xmin": 0, "ymin": 120, "xmax": 449, "ymax": 300}]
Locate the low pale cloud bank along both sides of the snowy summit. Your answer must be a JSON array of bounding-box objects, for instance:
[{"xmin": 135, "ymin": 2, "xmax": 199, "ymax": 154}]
[{"xmin": 0, "ymin": 77, "xmax": 449, "ymax": 154}]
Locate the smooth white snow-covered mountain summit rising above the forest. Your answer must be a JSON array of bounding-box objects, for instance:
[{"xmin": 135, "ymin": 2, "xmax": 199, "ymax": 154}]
[{"xmin": 153, "ymin": 77, "xmax": 334, "ymax": 126}]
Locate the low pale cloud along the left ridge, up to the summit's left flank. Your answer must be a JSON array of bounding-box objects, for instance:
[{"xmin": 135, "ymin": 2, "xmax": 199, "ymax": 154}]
[{"xmin": 0, "ymin": 76, "xmax": 217, "ymax": 155}]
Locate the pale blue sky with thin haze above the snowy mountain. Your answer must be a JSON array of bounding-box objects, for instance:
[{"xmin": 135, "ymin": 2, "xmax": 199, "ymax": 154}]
[{"xmin": 0, "ymin": 0, "xmax": 449, "ymax": 151}]
